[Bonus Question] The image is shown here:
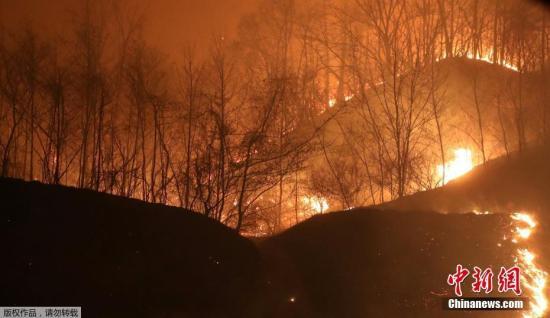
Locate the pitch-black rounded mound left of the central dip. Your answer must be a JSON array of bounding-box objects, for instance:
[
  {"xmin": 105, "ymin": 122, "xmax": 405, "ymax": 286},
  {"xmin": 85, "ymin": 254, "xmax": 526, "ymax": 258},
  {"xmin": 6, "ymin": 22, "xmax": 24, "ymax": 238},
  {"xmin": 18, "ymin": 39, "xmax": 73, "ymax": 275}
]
[{"xmin": 0, "ymin": 179, "xmax": 260, "ymax": 317}]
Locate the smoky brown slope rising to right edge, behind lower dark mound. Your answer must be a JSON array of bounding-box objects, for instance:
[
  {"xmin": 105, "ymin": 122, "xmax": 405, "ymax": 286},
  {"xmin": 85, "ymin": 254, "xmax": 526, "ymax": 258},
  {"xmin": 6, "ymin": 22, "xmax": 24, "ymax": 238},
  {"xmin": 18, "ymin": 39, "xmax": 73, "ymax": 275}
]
[{"xmin": 380, "ymin": 146, "xmax": 550, "ymax": 213}]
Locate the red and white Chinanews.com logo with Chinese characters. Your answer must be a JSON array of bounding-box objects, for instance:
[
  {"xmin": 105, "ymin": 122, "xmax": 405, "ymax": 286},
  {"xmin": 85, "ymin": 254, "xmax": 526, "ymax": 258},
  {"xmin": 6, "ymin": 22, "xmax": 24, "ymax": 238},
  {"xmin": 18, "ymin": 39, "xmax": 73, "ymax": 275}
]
[{"xmin": 443, "ymin": 264, "xmax": 529, "ymax": 310}]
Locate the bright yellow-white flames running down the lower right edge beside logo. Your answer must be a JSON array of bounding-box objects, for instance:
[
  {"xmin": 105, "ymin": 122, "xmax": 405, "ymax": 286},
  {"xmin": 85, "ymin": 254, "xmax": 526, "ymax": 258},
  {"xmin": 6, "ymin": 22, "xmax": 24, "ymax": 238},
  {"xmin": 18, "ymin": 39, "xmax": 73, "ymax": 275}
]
[{"xmin": 511, "ymin": 212, "xmax": 548, "ymax": 318}]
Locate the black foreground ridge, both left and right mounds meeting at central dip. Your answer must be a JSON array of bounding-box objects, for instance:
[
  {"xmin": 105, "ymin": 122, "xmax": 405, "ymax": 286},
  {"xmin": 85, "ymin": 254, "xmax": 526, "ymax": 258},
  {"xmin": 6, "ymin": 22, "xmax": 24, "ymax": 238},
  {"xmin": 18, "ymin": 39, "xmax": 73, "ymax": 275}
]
[{"xmin": 0, "ymin": 179, "xmax": 536, "ymax": 318}]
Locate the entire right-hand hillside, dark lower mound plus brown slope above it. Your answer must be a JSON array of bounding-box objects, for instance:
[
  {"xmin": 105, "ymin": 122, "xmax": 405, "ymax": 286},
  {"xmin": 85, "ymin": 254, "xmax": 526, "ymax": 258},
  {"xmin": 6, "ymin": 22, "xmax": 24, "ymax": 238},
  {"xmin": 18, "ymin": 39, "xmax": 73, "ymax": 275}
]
[{"xmin": 262, "ymin": 147, "xmax": 550, "ymax": 317}]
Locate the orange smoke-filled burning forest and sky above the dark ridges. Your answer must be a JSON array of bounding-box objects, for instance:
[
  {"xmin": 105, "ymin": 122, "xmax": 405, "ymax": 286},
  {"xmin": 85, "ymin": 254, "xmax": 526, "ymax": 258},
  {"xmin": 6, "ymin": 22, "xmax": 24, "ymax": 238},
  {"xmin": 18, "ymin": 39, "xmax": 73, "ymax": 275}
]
[{"xmin": 0, "ymin": 0, "xmax": 550, "ymax": 235}]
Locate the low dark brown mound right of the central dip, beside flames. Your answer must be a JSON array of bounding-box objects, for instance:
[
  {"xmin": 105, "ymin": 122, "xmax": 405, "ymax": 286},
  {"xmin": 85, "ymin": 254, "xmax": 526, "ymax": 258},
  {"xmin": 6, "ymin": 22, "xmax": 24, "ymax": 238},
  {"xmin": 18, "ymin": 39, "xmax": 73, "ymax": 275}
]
[{"xmin": 263, "ymin": 209, "xmax": 520, "ymax": 317}]
